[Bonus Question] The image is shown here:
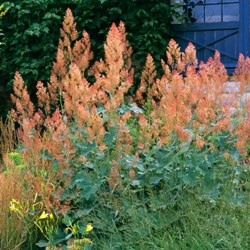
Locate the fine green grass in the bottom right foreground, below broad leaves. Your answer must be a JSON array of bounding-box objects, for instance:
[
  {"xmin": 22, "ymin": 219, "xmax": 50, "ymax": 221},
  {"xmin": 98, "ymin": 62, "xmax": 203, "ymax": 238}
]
[{"xmin": 92, "ymin": 191, "xmax": 250, "ymax": 250}]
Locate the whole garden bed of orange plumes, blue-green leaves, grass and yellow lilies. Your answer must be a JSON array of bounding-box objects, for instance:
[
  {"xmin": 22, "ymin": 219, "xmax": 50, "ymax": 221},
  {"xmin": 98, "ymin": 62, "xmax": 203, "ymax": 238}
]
[{"xmin": 0, "ymin": 9, "xmax": 250, "ymax": 249}]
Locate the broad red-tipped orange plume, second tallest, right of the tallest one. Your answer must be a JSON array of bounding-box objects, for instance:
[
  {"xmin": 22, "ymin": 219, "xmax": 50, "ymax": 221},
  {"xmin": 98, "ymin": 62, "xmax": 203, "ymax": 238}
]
[{"xmin": 91, "ymin": 22, "xmax": 133, "ymax": 110}]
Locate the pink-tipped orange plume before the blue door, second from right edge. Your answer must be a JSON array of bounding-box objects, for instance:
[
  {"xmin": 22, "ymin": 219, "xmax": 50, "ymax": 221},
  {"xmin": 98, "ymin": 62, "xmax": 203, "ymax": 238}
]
[{"xmin": 195, "ymin": 51, "xmax": 232, "ymax": 132}]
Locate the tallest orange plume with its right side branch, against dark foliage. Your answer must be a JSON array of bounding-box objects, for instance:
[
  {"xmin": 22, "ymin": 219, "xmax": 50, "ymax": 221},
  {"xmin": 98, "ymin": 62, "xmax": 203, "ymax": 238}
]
[{"xmin": 48, "ymin": 9, "xmax": 93, "ymax": 108}]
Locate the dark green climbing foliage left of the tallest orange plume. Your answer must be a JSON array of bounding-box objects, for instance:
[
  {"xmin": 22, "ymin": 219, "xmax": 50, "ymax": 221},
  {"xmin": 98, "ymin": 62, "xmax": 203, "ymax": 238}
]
[{"xmin": 0, "ymin": 0, "xmax": 64, "ymax": 92}]
